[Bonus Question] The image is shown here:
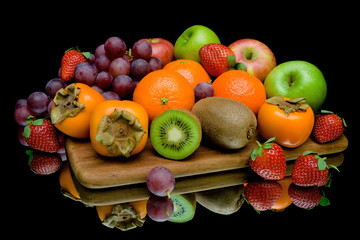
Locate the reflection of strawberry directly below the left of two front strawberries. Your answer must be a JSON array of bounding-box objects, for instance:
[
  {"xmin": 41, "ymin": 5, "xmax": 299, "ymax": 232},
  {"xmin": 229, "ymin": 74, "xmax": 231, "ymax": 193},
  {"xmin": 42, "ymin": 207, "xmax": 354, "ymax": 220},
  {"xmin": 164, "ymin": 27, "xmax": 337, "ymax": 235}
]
[{"xmin": 245, "ymin": 180, "xmax": 282, "ymax": 211}]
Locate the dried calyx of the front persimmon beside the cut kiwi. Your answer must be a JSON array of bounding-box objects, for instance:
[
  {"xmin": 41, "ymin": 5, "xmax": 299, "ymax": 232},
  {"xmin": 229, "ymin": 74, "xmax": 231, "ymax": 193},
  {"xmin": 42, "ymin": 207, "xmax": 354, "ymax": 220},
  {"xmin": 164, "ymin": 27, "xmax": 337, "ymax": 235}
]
[{"xmin": 95, "ymin": 108, "xmax": 145, "ymax": 157}]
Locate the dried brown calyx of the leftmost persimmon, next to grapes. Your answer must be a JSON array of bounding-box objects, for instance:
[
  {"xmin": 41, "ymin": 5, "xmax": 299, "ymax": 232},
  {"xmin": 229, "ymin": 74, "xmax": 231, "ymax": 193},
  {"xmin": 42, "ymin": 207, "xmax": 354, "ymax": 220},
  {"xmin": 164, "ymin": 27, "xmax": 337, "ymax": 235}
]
[{"xmin": 50, "ymin": 83, "xmax": 85, "ymax": 124}]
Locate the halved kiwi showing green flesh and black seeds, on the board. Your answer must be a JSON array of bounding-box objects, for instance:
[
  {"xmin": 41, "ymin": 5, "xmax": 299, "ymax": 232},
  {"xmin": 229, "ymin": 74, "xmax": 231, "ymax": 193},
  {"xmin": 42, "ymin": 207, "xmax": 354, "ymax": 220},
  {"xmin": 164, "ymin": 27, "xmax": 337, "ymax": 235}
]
[{"xmin": 150, "ymin": 109, "xmax": 202, "ymax": 160}]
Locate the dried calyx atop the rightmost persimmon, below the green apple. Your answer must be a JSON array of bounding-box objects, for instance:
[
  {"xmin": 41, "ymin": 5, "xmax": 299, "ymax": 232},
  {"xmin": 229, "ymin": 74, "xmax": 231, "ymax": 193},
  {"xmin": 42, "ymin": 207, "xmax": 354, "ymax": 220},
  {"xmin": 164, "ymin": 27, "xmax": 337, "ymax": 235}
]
[{"xmin": 266, "ymin": 96, "xmax": 309, "ymax": 115}]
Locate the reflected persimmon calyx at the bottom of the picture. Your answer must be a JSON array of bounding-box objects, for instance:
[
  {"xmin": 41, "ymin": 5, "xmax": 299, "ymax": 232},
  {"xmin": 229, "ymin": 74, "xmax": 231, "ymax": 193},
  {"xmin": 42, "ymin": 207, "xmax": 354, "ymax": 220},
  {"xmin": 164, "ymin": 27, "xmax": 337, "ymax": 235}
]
[{"xmin": 102, "ymin": 203, "xmax": 145, "ymax": 231}]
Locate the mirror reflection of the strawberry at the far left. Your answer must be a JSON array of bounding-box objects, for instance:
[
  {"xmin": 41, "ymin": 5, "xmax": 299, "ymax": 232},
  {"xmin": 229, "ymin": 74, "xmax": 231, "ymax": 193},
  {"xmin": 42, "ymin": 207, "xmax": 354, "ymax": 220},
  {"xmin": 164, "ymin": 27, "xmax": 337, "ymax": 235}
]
[{"xmin": 26, "ymin": 150, "xmax": 62, "ymax": 175}]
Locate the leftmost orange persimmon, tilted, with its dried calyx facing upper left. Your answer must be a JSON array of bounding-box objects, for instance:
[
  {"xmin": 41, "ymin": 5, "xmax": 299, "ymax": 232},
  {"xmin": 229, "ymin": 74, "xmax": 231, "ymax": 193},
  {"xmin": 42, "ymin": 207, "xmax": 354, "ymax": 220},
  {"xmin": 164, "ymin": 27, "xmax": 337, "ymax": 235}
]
[{"xmin": 51, "ymin": 83, "xmax": 105, "ymax": 138}]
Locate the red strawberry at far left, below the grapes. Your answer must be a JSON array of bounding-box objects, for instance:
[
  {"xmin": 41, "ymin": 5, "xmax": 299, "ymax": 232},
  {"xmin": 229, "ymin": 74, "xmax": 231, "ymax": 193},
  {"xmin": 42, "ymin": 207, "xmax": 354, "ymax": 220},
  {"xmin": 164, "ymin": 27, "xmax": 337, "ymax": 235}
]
[{"xmin": 23, "ymin": 116, "xmax": 60, "ymax": 152}]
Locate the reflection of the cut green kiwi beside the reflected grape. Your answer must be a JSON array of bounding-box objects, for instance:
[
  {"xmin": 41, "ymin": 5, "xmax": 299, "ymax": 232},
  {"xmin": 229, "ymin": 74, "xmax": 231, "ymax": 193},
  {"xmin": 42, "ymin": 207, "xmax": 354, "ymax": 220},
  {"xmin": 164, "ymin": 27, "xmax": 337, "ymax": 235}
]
[{"xmin": 169, "ymin": 193, "xmax": 196, "ymax": 223}]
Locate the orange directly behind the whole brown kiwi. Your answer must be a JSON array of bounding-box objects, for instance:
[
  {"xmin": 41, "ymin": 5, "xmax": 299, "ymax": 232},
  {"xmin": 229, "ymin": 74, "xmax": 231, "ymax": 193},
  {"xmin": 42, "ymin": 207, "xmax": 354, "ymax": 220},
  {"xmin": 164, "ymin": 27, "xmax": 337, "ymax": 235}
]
[{"xmin": 212, "ymin": 70, "xmax": 266, "ymax": 115}]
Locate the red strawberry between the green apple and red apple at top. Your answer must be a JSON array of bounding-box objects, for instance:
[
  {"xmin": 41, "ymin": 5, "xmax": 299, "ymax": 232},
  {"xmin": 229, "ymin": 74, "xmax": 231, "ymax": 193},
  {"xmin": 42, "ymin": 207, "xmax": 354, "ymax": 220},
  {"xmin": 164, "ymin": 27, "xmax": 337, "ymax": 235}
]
[{"xmin": 199, "ymin": 43, "xmax": 246, "ymax": 77}]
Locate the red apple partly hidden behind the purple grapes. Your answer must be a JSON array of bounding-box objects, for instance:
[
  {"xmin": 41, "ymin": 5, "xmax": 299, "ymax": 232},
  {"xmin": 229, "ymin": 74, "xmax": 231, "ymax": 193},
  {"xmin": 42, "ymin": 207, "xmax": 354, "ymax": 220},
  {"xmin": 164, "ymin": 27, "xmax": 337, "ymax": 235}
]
[{"xmin": 141, "ymin": 38, "xmax": 174, "ymax": 66}]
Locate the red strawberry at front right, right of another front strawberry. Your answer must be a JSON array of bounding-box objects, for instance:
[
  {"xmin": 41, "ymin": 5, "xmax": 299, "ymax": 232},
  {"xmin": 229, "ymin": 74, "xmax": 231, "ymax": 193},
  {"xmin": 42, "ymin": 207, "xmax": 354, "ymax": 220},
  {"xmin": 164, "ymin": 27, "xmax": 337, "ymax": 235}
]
[{"xmin": 291, "ymin": 151, "xmax": 329, "ymax": 187}]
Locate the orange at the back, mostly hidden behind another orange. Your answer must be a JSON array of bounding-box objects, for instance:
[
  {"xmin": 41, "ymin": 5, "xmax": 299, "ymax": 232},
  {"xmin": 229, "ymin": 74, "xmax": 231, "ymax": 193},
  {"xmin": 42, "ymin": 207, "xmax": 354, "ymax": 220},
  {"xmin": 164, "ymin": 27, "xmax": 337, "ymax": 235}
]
[{"xmin": 163, "ymin": 59, "xmax": 211, "ymax": 88}]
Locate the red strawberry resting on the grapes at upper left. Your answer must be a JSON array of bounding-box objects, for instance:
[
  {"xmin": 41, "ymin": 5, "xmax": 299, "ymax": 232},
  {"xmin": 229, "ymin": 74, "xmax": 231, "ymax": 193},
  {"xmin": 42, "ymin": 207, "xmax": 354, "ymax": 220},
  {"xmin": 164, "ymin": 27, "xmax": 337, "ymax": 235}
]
[{"xmin": 61, "ymin": 48, "xmax": 90, "ymax": 81}]
